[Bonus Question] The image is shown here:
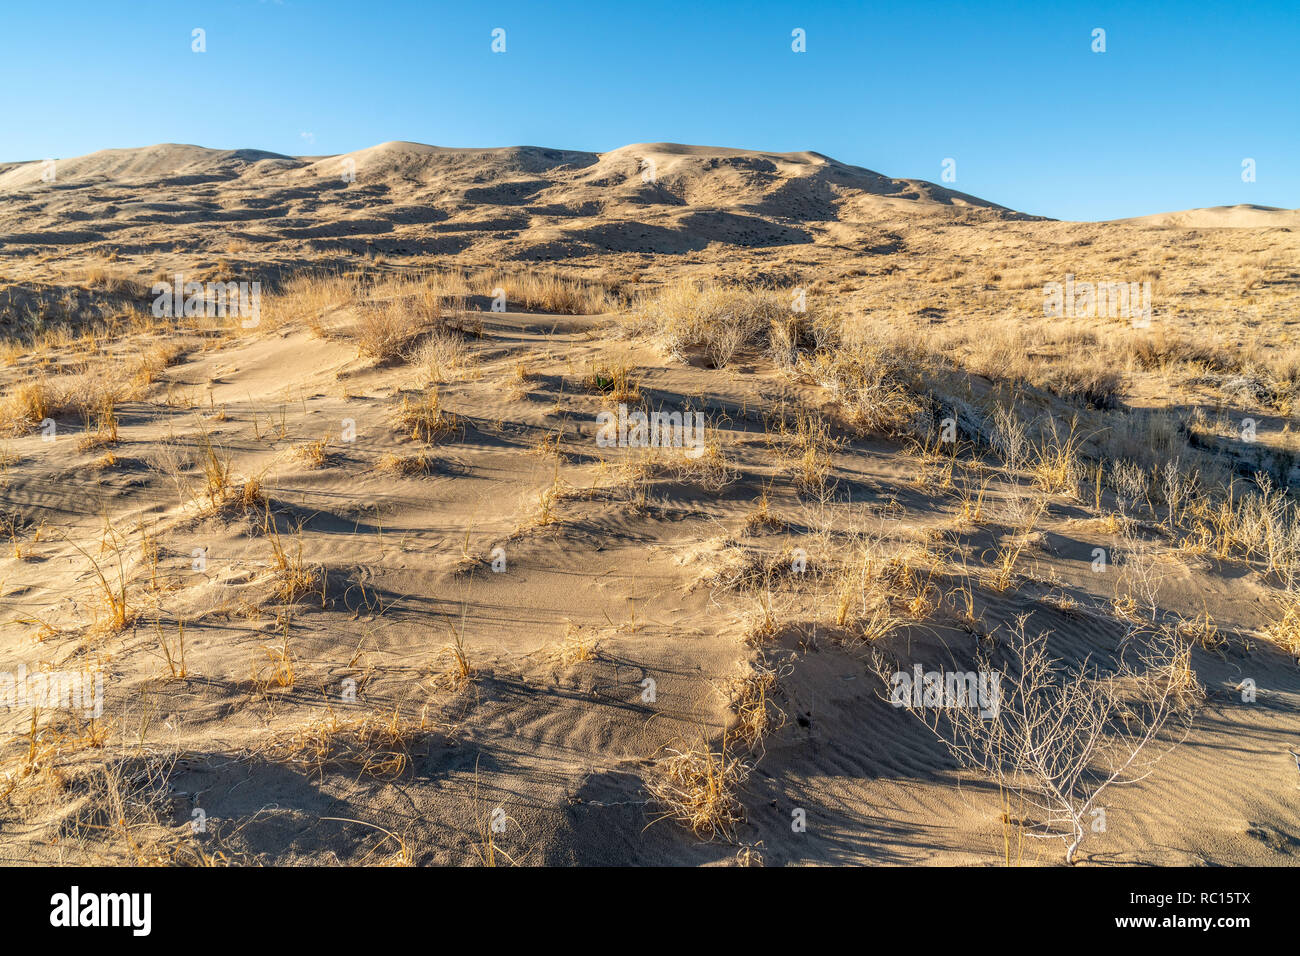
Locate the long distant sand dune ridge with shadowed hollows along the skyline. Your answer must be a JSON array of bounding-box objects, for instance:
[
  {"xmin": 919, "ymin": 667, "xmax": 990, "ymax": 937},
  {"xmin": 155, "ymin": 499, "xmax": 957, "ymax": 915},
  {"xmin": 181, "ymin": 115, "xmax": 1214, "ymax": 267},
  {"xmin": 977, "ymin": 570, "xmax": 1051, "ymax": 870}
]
[{"xmin": 0, "ymin": 142, "xmax": 1045, "ymax": 280}]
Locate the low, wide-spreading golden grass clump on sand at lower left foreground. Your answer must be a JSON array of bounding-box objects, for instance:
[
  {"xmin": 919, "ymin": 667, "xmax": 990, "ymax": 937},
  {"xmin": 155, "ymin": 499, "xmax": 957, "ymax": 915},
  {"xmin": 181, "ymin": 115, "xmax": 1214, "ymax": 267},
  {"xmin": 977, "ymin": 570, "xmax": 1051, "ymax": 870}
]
[{"xmin": 270, "ymin": 708, "xmax": 432, "ymax": 780}]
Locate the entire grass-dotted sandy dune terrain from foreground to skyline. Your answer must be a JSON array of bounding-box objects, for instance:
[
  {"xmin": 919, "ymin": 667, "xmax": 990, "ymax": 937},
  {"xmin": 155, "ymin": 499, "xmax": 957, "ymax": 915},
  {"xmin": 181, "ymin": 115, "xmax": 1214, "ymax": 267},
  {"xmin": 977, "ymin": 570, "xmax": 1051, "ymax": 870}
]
[{"xmin": 0, "ymin": 142, "xmax": 1300, "ymax": 865}]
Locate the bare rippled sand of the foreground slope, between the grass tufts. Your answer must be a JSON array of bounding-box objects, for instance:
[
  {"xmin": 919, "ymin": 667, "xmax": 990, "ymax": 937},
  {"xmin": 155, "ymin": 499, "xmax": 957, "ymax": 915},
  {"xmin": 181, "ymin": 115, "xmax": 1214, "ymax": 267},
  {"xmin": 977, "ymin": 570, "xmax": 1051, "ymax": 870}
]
[{"xmin": 0, "ymin": 304, "xmax": 1300, "ymax": 864}]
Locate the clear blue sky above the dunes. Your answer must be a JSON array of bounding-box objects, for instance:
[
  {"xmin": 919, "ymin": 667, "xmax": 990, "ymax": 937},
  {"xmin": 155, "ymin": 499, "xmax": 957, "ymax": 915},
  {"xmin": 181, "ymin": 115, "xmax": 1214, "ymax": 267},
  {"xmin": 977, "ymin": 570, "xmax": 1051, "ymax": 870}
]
[{"xmin": 0, "ymin": 0, "xmax": 1300, "ymax": 220}]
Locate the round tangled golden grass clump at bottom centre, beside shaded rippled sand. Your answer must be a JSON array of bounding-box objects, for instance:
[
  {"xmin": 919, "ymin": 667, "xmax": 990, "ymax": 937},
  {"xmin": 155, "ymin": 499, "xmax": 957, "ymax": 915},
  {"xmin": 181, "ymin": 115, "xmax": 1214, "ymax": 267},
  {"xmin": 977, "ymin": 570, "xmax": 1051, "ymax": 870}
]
[{"xmin": 646, "ymin": 737, "xmax": 751, "ymax": 840}]
